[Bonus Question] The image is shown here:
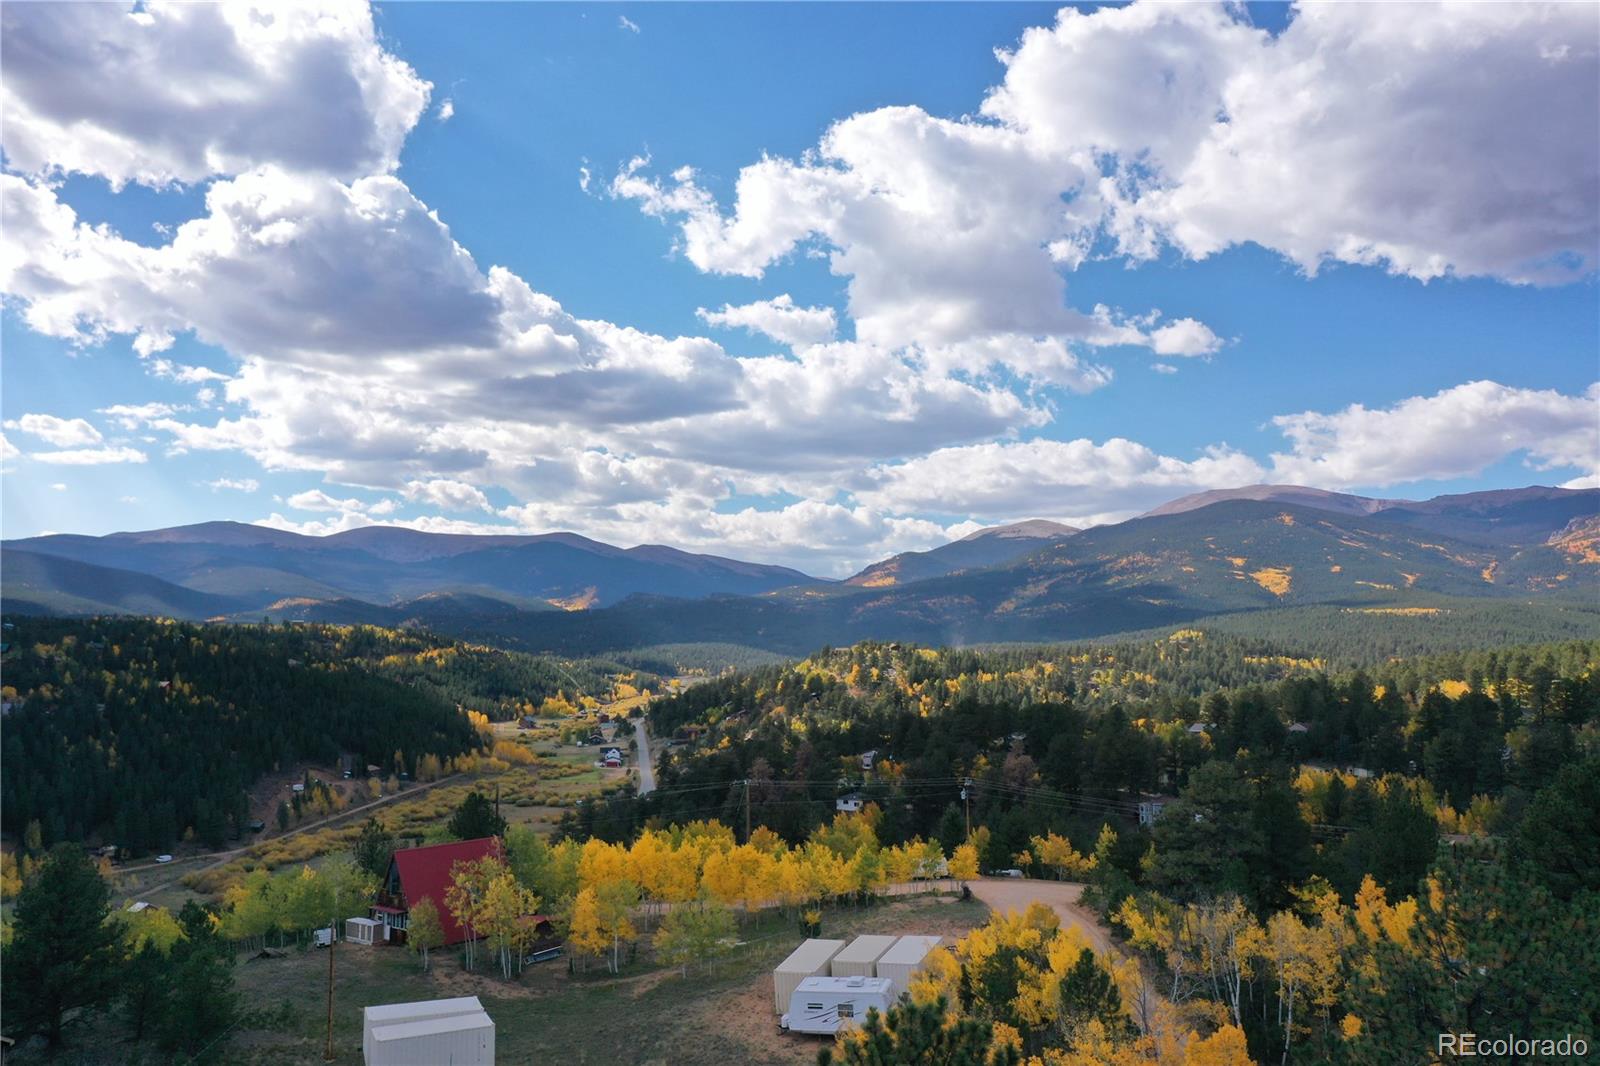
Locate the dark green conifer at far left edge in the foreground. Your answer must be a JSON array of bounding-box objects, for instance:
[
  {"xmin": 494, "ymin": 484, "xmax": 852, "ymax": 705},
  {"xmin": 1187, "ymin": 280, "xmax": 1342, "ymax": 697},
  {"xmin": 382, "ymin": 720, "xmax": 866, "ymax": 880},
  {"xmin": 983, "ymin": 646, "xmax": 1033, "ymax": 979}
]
[{"xmin": 3, "ymin": 844, "xmax": 122, "ymax": 1047}]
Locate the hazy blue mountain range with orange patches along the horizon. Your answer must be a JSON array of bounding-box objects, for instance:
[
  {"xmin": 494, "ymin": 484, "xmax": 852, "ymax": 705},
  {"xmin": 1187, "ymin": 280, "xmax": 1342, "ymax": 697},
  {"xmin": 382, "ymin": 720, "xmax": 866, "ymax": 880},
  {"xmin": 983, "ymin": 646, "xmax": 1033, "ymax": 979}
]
[{"xmin": 3, "ymin": 485, "xmax": 1600, "ymax": 653}]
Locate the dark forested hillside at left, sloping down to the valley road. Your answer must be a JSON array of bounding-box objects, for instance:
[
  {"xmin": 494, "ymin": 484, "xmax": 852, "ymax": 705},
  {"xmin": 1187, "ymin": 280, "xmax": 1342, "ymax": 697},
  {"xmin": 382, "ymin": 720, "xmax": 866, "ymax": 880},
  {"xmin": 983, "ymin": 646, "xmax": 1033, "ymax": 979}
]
[{"xmin": 0, "ymin": 618, "xmax": 649, "ymax": 855}]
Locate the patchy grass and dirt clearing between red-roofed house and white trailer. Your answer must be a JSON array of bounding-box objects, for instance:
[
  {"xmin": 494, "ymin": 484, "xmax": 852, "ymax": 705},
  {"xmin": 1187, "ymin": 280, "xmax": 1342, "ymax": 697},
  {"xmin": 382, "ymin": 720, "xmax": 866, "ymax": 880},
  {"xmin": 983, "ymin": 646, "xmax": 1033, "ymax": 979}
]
[{"xmin": 226, "ymin": 896, "xmax": 989, "ymax": 1066}]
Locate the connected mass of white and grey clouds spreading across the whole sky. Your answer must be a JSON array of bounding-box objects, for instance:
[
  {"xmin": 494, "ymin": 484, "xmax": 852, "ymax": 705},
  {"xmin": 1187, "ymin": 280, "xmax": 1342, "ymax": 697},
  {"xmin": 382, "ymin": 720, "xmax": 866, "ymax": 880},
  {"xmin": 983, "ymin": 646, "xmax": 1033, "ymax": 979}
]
[{"xmin": 0, "ymin": 3, "xmax": 1600, "ymax": 571}]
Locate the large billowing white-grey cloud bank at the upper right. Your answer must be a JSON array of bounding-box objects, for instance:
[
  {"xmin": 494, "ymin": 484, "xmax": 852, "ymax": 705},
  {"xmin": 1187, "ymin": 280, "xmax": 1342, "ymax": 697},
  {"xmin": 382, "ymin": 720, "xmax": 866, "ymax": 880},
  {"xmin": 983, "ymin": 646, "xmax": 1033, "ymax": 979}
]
[{"xmin": 613, "ymin": 3, "xmax": 1600, "ymax": 291}]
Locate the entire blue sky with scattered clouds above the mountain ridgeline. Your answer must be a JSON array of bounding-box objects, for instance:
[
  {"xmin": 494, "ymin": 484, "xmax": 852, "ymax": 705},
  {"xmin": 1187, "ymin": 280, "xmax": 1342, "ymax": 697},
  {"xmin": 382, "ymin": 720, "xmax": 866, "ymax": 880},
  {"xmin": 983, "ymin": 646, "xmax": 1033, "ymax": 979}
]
[{"xmin": 0, "ymin": 2, "xmax": 1600, "ymax": 576}]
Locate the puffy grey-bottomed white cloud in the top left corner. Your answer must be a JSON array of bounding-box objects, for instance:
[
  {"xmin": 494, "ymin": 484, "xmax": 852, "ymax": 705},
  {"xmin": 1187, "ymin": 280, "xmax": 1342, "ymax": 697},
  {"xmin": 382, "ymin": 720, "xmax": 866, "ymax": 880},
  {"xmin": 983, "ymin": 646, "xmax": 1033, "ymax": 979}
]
[{"xmin": 0, "ymin": 2, "xmax": 430, "ymax": 186}]
